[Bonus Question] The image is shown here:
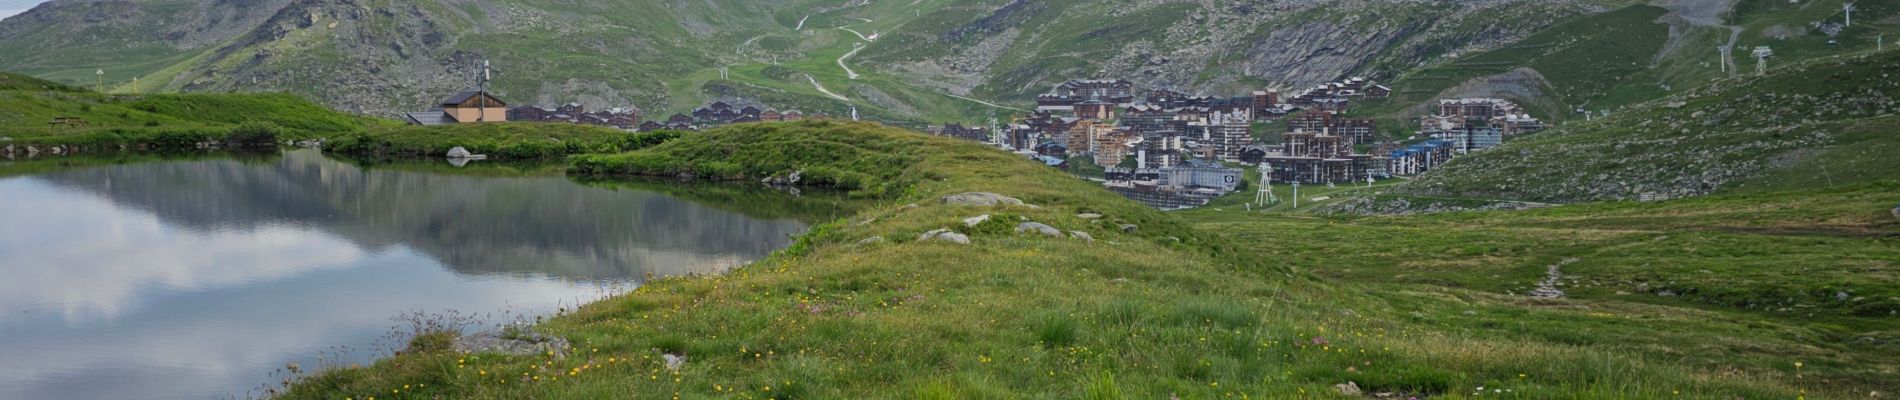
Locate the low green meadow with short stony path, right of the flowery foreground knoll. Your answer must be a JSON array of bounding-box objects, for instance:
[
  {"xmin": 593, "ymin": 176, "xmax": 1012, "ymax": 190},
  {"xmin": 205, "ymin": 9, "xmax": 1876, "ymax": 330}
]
[{"xmin": 1188, "ymin": 182, "xmax": 1900, "ymax": 398}]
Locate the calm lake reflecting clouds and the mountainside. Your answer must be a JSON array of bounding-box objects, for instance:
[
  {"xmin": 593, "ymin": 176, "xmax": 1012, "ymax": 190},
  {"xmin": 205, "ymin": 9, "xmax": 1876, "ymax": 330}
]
[{"xmin": 0, "ymin": 152, "xmax": 806, "ymax": 398}]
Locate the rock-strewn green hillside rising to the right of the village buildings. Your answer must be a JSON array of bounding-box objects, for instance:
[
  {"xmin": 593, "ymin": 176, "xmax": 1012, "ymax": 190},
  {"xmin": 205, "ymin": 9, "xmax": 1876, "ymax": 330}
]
[{"xmin": 1404, "ymin": 51, "xmax": 1900, "ymax": 203}]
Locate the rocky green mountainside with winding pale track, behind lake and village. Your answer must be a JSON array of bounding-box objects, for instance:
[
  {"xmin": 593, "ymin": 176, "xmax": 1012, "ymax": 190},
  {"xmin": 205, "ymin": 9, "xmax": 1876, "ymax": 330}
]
[{"xmin": 0, "ymin": 0, "xmax": 1606, "ymax": 119}]
